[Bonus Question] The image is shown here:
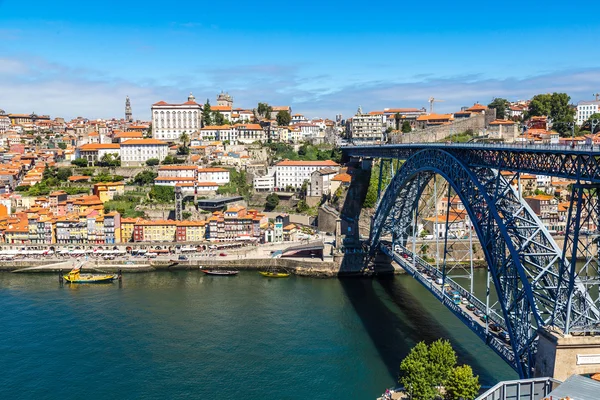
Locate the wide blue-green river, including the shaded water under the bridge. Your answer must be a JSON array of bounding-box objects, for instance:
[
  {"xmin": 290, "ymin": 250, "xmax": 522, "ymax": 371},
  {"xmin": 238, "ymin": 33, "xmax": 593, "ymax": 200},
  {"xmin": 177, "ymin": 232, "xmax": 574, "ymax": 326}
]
[{"xmin": 0, "ymin": 270, "xmax": 516, "ymax": 400}]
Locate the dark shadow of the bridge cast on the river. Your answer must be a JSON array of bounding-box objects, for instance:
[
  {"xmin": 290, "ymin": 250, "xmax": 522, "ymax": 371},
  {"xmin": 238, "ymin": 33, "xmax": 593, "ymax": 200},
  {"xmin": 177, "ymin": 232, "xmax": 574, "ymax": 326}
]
[{"xmin": 340, "ymin": 276, "xmax": 500, "ymax": 384}]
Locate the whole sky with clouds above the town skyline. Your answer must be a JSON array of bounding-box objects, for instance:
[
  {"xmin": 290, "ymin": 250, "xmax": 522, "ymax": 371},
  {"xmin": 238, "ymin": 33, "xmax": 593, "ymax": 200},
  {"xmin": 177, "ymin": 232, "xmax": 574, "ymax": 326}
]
[{"xmin": 0, "ymin": 0, "xmax": 600, "ymax": 119}]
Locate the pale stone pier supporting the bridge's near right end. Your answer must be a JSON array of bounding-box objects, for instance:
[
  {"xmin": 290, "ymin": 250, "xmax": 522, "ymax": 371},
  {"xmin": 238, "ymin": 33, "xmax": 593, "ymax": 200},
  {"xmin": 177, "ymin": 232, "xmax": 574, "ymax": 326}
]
[{"xmin": 534, "ymin": 328, "xmax": 600, "ymax": 381}]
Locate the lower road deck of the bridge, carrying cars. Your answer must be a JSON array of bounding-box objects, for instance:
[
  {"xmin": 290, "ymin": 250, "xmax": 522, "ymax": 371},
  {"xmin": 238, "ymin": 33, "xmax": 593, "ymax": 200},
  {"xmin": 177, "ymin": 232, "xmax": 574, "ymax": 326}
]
[{"xmin": 379, "ymin": 242, "xmax": 516, "ymax": 368}]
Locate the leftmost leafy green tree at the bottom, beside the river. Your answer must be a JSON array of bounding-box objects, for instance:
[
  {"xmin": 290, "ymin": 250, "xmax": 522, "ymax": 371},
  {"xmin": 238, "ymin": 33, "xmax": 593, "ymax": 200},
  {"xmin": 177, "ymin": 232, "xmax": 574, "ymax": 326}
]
[{"xmin": 399, "ymin": 342, "xmax": 437, "ymax": 400}]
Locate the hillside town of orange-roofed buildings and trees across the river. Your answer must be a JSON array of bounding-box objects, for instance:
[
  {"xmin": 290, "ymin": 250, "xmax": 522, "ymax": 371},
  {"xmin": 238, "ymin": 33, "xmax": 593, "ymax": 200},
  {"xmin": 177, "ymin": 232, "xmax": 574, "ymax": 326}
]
[{"xmin": 0, "ymin": 92, "xmax": 600, "ymax": 245}]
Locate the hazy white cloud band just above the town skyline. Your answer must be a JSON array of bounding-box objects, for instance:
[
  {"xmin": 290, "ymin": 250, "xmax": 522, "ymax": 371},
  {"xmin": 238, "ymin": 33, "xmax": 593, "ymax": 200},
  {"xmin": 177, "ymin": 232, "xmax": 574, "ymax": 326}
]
[{"xmin": 0, "ymin": 58, "xmax": 600, "ymax": 119}]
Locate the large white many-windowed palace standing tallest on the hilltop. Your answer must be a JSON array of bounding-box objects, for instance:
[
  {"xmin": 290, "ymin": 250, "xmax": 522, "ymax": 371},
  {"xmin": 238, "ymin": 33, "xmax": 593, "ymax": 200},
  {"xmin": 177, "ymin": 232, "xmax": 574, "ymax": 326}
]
[{"xmin": 152, "ymin": 93, "xmax": 202, "ymax": 142}]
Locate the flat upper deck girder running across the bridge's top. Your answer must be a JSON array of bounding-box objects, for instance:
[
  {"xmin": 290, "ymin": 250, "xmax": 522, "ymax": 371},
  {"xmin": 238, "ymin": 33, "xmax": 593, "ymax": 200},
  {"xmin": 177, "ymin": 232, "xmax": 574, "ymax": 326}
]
[{"xmin": 342, "ymin": 143, "xmax": 600, "ymax": 183}]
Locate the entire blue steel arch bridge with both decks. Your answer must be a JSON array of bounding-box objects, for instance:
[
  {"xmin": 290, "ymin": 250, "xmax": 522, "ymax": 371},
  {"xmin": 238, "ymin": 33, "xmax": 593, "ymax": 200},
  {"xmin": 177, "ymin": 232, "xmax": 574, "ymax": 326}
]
[{"xmin": 343, "ymin": 144, "xmax": 600, "ymax": 377}]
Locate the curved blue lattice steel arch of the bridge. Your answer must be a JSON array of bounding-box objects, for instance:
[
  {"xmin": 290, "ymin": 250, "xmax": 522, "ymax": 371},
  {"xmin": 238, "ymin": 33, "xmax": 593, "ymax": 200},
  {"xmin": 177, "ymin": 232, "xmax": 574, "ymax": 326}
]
[{"xmin": 370, "ymin": 149, "xmax": 589, "ymax": 376}]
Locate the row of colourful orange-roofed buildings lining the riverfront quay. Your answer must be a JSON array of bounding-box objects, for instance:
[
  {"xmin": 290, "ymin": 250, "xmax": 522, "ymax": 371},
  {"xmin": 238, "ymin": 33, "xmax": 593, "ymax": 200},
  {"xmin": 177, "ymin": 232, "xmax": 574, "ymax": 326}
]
[{"xmin": 0, "ymin": 197, "xmax": 300, "ymax": 245}]
